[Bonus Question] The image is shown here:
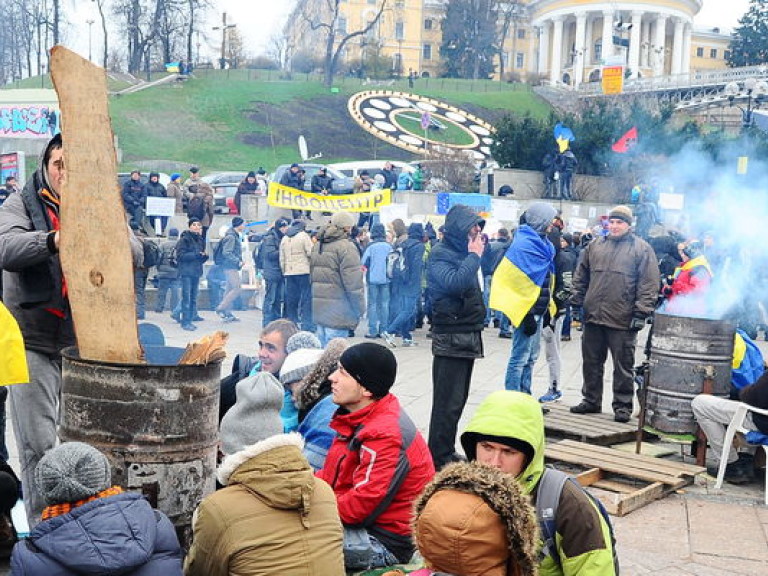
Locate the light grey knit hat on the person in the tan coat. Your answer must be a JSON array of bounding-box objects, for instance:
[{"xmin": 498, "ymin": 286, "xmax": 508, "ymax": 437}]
[{"xmin": 219, "ymin": 372, "xmax": 283, "ymax": 456}]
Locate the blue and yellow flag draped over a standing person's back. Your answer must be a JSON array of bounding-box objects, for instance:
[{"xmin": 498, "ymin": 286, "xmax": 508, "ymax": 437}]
[{"xmin": 489, "ymin": 225, "xmax": 556, "ymax": 327}]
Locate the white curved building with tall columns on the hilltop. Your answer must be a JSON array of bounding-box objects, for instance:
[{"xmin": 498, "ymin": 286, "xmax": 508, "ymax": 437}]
[{"xmin": 528, "ymin": 0, "xmax": 728, "ymax": 86}]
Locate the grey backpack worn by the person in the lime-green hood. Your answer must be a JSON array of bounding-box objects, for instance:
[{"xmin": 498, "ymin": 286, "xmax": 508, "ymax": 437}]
[{"xmin": 536, "ymin": 467, "xmax": 619, "ymax": 576}]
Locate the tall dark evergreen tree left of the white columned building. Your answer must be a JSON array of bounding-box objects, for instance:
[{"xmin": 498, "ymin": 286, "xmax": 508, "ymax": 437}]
[{"xmin": 440, "ymin": 0, "xmax": 498, "ymax": 80}]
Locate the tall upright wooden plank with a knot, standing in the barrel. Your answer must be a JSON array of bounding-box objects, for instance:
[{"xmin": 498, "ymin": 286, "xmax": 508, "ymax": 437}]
[{"xmin": 50, "ymin": 46, "xmax": 142, "ymax": 364}]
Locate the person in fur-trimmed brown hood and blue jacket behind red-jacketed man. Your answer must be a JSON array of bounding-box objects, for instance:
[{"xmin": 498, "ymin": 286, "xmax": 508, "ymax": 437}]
[{"xmin": 293, "ymin": 338, "xmax": 349, "ymax": 470}]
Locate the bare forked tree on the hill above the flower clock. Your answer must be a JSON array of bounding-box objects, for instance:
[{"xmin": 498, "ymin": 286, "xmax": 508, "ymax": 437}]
[{"xmin": 296, "ymin": 0, "xmax": 388, "ymax": 87}]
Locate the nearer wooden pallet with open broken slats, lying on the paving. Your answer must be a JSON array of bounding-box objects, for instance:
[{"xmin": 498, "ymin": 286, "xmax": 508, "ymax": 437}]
[{"xmin": 545, "ymin": 440, "xmax": 706, "ymax": 516}]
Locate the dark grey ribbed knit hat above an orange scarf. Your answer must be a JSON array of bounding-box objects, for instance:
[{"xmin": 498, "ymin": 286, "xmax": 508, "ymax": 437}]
[{"xmin": 35, "ymin": 442, "xmax": 112, "ymax": 506}]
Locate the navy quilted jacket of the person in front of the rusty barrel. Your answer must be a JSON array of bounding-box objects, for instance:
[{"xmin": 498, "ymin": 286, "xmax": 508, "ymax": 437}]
[{"xmin": 11, "ymin": 493, "xmax": 181, "ymax": 576}]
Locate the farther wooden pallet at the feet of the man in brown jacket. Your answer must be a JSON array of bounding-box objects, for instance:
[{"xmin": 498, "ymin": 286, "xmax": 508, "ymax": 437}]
[{"xmin": 544, "ymin": 404, "xmax": 652, "ymax": 446}]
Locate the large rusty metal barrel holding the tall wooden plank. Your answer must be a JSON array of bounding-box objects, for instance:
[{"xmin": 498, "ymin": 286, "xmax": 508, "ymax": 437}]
[{"xmin": 59, "ymin": 348, "xmax": 221, "ymax": 549}]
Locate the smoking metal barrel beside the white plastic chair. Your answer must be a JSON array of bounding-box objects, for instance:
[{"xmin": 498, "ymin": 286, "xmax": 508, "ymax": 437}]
[{"xmin": 646, "ymin": 312, "xmax": 736, "ymax": 435}]
